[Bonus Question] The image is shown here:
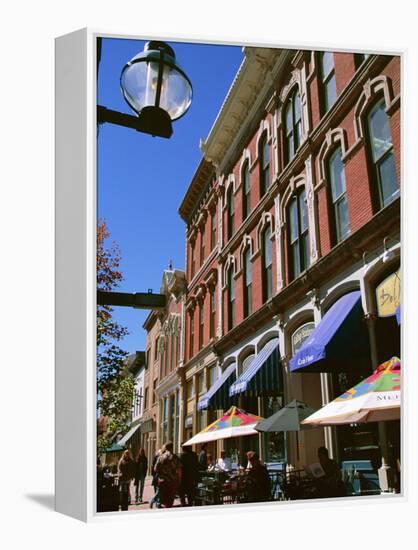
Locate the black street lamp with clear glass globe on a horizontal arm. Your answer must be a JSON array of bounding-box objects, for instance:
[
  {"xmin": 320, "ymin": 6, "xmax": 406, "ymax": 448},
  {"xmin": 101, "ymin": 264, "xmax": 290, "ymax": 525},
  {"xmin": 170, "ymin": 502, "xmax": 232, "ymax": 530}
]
[{"xmin": 97, "ymin": 40, "xmax": 193, "ymax": 138}]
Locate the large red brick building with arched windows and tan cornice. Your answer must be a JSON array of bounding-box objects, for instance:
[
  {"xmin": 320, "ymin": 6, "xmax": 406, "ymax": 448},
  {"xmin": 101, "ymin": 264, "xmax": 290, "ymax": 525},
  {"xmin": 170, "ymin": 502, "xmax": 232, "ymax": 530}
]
[{"xmin": 179, "ymin": 47, "xmax": 401, "ymax": 474}]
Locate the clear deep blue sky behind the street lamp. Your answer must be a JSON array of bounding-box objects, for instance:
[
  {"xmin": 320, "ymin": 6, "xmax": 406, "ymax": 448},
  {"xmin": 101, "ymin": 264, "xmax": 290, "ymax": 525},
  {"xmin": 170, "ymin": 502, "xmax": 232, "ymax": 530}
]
[{"xmin": 97, "ymin": 39, "xmax": 243, "ymax": 352}]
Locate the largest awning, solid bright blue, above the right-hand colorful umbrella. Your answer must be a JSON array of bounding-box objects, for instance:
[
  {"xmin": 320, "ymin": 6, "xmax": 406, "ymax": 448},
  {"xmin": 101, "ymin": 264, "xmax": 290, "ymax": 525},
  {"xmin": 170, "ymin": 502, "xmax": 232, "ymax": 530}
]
[{"xmin": 290, "ymin": 291, "xmax": 370, "ymax": 372}]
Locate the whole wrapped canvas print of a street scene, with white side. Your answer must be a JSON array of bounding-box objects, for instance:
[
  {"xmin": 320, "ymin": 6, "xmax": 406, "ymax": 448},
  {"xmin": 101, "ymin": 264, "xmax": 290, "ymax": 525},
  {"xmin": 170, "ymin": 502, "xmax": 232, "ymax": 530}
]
[{"xmin": 56, "ymin": 29, "xmax": 404, "ymax": 520}]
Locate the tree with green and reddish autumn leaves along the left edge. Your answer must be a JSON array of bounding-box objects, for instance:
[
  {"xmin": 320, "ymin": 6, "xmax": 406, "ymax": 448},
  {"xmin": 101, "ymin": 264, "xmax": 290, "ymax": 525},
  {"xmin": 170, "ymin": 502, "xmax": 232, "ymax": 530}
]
[{"xmin": 97, "ymin": 220, "xmax": 134, "ymax": 453}]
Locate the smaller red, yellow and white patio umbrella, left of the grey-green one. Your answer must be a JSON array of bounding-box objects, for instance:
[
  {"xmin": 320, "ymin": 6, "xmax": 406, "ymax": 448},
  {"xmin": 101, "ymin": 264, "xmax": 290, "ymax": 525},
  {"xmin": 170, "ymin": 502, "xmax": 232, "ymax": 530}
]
[{"xmin": 186, "ymin": 406, "xmax": 262, "ymax": 445}]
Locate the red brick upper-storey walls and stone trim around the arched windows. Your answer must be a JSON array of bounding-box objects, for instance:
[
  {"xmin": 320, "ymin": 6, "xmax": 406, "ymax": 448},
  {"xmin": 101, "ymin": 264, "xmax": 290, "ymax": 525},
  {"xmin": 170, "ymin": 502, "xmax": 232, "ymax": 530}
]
[{"xmin": 180, "ymin": 52, "xmax": 401, "ymax": 363}]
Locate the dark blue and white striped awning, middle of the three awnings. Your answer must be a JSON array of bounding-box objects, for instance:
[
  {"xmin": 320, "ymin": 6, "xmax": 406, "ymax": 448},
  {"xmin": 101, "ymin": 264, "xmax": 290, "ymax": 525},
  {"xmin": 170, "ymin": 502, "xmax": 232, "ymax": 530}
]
[{"xmin": 229, "ymin": 338, "xmax": 283, "ymax": 397}]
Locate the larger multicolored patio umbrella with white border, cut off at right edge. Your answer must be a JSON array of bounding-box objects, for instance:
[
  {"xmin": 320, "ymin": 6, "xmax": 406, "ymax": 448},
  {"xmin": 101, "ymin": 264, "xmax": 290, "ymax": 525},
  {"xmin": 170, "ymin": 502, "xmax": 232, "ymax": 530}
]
[{"xmin": 302, "ymin": 357, "xmax": 401, "ymax": 426}]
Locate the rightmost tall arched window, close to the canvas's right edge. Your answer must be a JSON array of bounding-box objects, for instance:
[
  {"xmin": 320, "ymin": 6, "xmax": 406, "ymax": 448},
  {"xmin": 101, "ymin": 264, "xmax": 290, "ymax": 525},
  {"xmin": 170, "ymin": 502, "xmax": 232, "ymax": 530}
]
[{"xmin": 367, "ymin": 98, "xmax": 399, "ymax": 210}]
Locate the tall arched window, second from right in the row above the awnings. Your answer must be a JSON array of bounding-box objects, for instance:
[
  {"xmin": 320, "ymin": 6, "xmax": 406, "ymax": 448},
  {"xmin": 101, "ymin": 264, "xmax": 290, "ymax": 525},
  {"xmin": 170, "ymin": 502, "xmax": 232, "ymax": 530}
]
[{"xmin": 328, "ymin": 147, "xmax": 350, "ymax": 244}]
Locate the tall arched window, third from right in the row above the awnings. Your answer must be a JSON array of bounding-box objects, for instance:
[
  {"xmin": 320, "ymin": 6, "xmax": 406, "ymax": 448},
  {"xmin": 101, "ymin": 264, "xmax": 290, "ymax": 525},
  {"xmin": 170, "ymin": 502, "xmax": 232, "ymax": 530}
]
[{"xmin": 288, "ymin": 190, "xmax": 309, "ymax": 280}]
